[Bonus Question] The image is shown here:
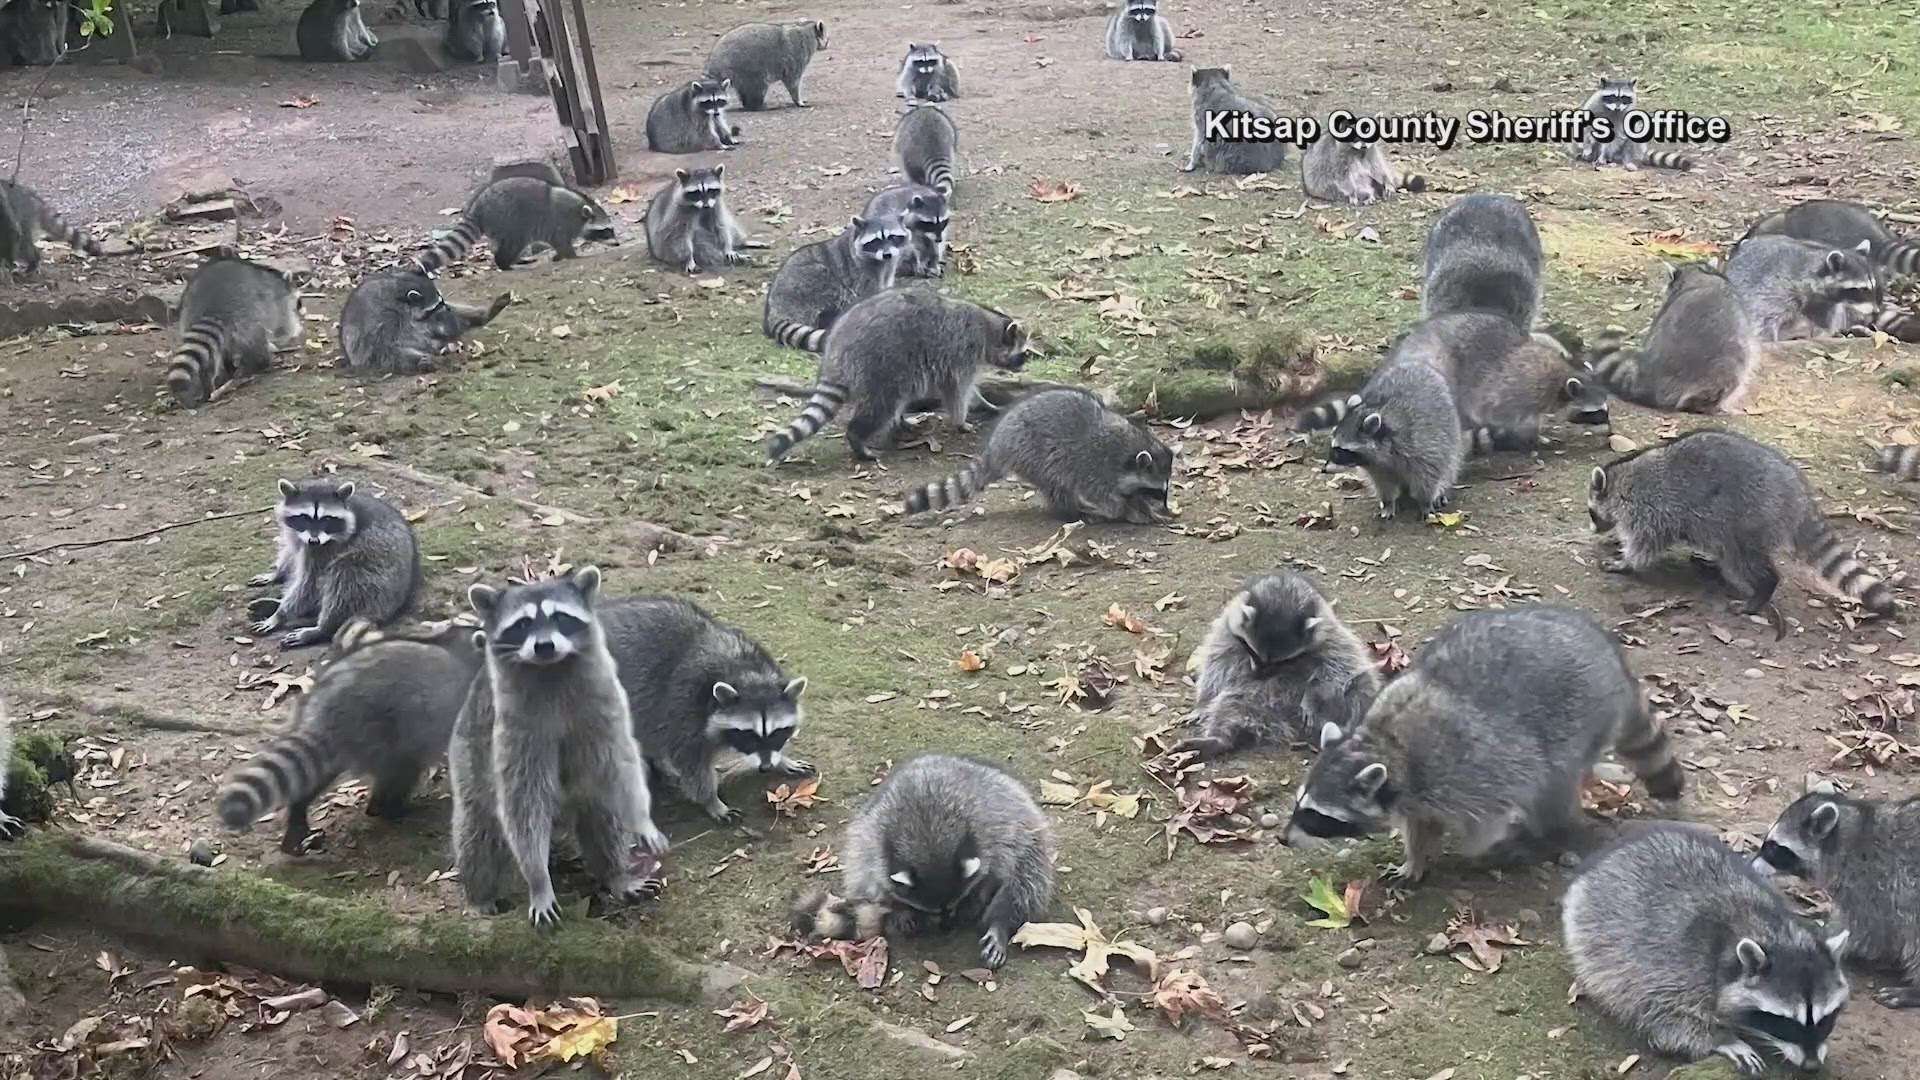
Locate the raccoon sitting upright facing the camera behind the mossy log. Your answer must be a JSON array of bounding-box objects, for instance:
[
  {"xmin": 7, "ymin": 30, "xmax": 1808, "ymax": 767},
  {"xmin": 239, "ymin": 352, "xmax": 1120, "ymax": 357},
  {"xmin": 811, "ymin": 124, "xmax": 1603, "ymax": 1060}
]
[{"xmin": 447, "ymin": 567, "xmax": 668, "ymax": 926}]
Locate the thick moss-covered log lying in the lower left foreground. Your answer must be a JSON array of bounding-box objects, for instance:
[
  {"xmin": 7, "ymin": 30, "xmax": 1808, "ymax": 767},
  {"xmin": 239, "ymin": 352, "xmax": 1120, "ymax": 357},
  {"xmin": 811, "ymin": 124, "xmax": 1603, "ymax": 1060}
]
[{"xmin": 0, "ymin": 828, "xmax": 728, "ymax": 1001}]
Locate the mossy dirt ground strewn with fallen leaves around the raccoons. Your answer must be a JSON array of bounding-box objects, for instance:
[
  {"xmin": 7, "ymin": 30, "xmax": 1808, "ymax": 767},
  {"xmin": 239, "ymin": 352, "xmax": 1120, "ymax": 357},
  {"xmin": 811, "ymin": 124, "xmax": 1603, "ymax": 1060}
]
[{"xmin": 0, "ymin": 0, "xmax": 1920, "ymax": 1080}]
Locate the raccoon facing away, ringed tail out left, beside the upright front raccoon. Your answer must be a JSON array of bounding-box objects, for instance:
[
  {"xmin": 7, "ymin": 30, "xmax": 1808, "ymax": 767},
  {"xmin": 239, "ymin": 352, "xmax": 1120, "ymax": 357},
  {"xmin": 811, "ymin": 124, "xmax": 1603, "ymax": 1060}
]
[{"xmin": 219, "ymin": 617, "xmax": 480, "ymax": 855}]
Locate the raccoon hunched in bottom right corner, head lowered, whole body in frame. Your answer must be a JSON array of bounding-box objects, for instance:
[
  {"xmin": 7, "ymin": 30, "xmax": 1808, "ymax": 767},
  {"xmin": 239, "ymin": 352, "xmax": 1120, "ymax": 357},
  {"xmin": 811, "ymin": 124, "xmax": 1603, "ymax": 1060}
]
[{"xmin": 1561, "ymin": 822, "xmax": 1849, "ymax": 1074}]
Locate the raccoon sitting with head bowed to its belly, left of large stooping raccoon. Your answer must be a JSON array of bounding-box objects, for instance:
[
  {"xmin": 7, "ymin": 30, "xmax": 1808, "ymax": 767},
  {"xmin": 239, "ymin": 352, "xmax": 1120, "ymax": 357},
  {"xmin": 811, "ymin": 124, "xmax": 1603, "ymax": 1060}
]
[{"xmin": 1169, "ymin": 571, "xmax": 1380, "ymax": 759}]
